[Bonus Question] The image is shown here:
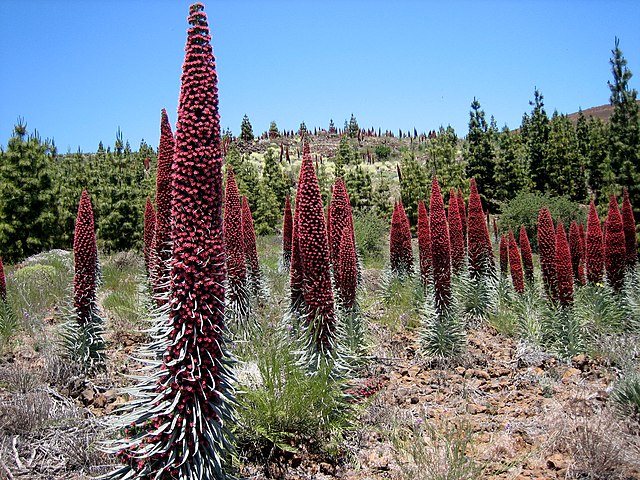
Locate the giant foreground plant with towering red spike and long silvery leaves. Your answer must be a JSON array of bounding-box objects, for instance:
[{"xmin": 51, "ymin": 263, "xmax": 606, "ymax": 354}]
[{"xmin": 111, "ymin": 4, "xmax": 233, "ymax": 480}]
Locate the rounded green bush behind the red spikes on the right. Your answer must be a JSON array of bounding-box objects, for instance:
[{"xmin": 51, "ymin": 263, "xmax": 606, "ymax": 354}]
[{"xmin": 499, "ymin": 192, "xmax": 587, "ymax": 252}]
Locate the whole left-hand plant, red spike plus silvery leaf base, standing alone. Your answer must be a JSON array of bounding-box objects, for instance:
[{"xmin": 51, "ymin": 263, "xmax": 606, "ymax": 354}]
[{"xmin": 62, "ymin": 190, "xmax": 104, "ymax": 371}]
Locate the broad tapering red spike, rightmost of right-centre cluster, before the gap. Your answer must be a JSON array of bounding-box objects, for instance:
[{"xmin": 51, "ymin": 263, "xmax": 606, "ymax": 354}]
[{"xmin": 467, "ymin": 178, "xmax": 495, "ymax": 276}]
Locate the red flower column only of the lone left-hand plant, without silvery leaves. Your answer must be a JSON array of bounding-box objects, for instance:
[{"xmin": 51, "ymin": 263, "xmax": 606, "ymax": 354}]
[{"xmin": 73, "ymin": 190, "xmax": 98, "ymax": 326}]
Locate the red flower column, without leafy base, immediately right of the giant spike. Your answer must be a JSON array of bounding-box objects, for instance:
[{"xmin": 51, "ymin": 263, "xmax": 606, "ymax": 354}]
[{"xmin": 224, "ymin": 164, "xmax": 247, "ymax": 306}]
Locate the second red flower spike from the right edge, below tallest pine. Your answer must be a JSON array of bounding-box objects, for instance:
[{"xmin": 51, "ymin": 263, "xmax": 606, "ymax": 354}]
[{"xmin": 604, "ymin": 195, "xmax": 627, "ymax": 291}]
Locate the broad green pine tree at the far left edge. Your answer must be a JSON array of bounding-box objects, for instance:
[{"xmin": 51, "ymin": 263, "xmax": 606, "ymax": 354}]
[{"xmin": 0, "ymin": 121, "xmax": 56, "ymax": 262}]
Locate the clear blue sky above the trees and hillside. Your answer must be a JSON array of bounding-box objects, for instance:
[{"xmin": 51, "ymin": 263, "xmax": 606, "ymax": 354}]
[{"xmin": 0, "ymin": 0, "xmax": 640, "ymax": 152}]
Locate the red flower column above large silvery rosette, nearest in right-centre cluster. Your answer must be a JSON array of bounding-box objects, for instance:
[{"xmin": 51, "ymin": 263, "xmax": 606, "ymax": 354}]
[{"xmin": 429, "ymin": 176, "xmax": 451, "ymax": 311}]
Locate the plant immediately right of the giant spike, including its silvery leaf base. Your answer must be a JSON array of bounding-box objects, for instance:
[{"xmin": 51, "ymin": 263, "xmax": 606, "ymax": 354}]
[{"xmin": 224, "ymin": 164, "xmax": 249, "ymax": 328}]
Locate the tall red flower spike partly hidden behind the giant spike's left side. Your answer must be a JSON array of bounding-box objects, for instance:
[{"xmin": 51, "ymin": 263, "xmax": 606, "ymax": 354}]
[{"xmin": 151, "ymin": 108, "xmax": 175, "ymax": 303}]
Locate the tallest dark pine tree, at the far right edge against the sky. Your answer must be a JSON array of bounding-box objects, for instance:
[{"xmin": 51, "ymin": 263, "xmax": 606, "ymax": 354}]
[{"xmin": 607, "ymin": 38, "xmax": 640, "ymax": 218}]
